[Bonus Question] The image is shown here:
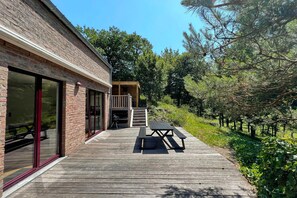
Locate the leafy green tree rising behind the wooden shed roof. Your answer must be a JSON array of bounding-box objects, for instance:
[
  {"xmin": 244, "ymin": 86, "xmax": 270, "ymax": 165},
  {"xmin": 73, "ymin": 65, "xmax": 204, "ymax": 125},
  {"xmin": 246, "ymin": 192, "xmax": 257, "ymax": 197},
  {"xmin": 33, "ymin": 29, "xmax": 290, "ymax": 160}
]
[{"xmin": 77, "ymin": 26, "xmax": 152, "ymax": 80}]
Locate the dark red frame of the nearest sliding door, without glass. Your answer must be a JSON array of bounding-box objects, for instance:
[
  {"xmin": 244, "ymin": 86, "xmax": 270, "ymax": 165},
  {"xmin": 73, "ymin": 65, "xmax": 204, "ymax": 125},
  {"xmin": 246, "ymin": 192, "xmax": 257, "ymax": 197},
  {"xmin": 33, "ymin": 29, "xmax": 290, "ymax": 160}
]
[{"xmin": 3, "ymin": 67, "xmax": 63, "ymax": 191}]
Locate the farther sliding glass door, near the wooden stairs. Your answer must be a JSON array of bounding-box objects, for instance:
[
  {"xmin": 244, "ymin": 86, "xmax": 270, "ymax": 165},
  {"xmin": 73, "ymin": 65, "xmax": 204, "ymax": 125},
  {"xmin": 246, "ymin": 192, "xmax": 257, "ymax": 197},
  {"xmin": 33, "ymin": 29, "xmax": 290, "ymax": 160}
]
[{"xmin": 86, "ymin": 90, "xmax": 103, "ymax": 139}]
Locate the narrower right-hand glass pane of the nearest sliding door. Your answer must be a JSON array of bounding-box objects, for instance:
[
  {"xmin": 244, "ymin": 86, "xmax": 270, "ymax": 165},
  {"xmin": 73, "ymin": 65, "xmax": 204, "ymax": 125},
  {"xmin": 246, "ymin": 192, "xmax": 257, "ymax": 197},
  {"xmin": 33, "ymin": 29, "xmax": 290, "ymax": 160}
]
[{"xmin": 40, "ymin": 79, "xmax": 59, "ymax": 162}]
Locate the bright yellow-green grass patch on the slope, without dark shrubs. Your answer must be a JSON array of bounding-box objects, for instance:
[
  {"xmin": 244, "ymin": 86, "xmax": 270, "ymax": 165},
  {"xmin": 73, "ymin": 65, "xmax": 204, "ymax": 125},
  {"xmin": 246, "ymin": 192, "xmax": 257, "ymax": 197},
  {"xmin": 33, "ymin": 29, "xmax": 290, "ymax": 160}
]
[{"xmin": 149, "ymin": 103, "xmax": 259, "ymax": 148}]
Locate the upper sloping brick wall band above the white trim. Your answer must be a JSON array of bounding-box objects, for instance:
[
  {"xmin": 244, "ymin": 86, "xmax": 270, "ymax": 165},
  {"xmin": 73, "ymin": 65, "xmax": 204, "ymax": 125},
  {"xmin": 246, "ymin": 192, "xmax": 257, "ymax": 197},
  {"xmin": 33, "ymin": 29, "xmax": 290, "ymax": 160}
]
[{"xmin": 0, "ymin": 0, "xmax": 110, "ymax": 82}]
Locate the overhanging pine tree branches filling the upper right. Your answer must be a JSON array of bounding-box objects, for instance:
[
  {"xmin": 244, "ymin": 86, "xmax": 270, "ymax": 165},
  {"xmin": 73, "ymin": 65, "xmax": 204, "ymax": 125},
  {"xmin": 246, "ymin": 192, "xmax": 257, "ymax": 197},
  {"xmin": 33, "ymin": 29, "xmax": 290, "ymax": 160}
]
[{"xmin": 182, "ymin": 0, "xmax": 297, "ymax": 128}]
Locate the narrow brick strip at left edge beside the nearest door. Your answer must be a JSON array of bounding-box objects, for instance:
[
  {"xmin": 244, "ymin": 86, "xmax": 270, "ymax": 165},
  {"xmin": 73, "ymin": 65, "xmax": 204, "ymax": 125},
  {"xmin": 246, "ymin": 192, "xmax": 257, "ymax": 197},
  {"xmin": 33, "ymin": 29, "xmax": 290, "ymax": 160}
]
[{"xmin": 0, "ymin": 66, "xmax": 8, "ymax": 197}]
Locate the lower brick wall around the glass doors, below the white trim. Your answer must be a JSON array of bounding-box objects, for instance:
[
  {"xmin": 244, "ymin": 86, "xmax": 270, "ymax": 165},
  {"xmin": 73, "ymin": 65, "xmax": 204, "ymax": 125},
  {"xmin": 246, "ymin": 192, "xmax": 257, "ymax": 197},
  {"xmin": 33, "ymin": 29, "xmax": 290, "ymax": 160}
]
[{"xmin": 0, "ymin": 39, "xmax": 109, "ymax": 155}]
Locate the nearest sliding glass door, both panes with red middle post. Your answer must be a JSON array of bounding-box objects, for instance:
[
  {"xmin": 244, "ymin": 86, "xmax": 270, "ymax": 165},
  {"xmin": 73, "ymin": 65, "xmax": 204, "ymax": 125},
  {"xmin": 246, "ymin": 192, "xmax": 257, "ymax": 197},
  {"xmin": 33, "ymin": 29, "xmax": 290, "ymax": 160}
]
[{"xmin": 4, "ymin": 71, "xmax": 61, "ymax": 187}]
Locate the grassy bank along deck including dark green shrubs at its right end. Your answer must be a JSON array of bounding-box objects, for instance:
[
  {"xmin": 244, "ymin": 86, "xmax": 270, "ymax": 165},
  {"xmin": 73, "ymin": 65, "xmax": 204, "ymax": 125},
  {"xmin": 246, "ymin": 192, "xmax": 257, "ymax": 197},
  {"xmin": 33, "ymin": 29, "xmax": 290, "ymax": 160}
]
[{"xmin": 149, "ymin": 102, "xmax": 262, "ymax": 182}]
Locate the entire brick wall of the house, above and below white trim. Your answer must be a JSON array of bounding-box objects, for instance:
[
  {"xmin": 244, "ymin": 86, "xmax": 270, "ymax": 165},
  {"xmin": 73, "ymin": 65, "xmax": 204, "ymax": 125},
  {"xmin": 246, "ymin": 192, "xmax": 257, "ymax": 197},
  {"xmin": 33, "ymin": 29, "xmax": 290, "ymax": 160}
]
[{"xmin": 0, "ymin": 0, "xmax": 111, "ymax": 192}]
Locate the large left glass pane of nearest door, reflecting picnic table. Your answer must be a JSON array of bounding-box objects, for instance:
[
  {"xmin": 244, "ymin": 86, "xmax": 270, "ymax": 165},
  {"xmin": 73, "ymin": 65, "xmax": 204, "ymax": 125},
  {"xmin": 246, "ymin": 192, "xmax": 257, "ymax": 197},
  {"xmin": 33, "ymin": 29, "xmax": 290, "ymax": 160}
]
[{"xmin": 3, "ymin": 71, "xmax": 35, "ymax": 182}]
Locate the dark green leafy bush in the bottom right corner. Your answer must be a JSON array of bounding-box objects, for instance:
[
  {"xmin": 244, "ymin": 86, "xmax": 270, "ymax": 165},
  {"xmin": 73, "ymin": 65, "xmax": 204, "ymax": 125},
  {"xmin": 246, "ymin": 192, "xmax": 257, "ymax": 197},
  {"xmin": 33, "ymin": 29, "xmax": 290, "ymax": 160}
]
[{"xmin": 257, "ymin": 138, "xmax": 297, "ymax": 197}]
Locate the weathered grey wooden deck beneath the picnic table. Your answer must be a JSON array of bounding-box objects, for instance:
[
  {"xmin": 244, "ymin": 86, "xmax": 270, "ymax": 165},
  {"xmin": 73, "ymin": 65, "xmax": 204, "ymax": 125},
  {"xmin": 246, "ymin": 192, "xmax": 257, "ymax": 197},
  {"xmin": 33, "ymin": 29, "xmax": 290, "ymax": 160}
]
[{"xmin": 10, "ymin": 128, "xmax": 255, "ymax": 198}]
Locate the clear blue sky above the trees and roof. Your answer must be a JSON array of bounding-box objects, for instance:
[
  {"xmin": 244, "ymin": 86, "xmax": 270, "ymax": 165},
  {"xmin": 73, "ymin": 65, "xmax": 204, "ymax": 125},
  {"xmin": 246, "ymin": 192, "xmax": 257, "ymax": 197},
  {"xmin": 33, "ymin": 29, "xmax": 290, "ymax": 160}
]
[{"xmin": 52, "ymin": 0, "xmax": 202, "ymax": 54}]
